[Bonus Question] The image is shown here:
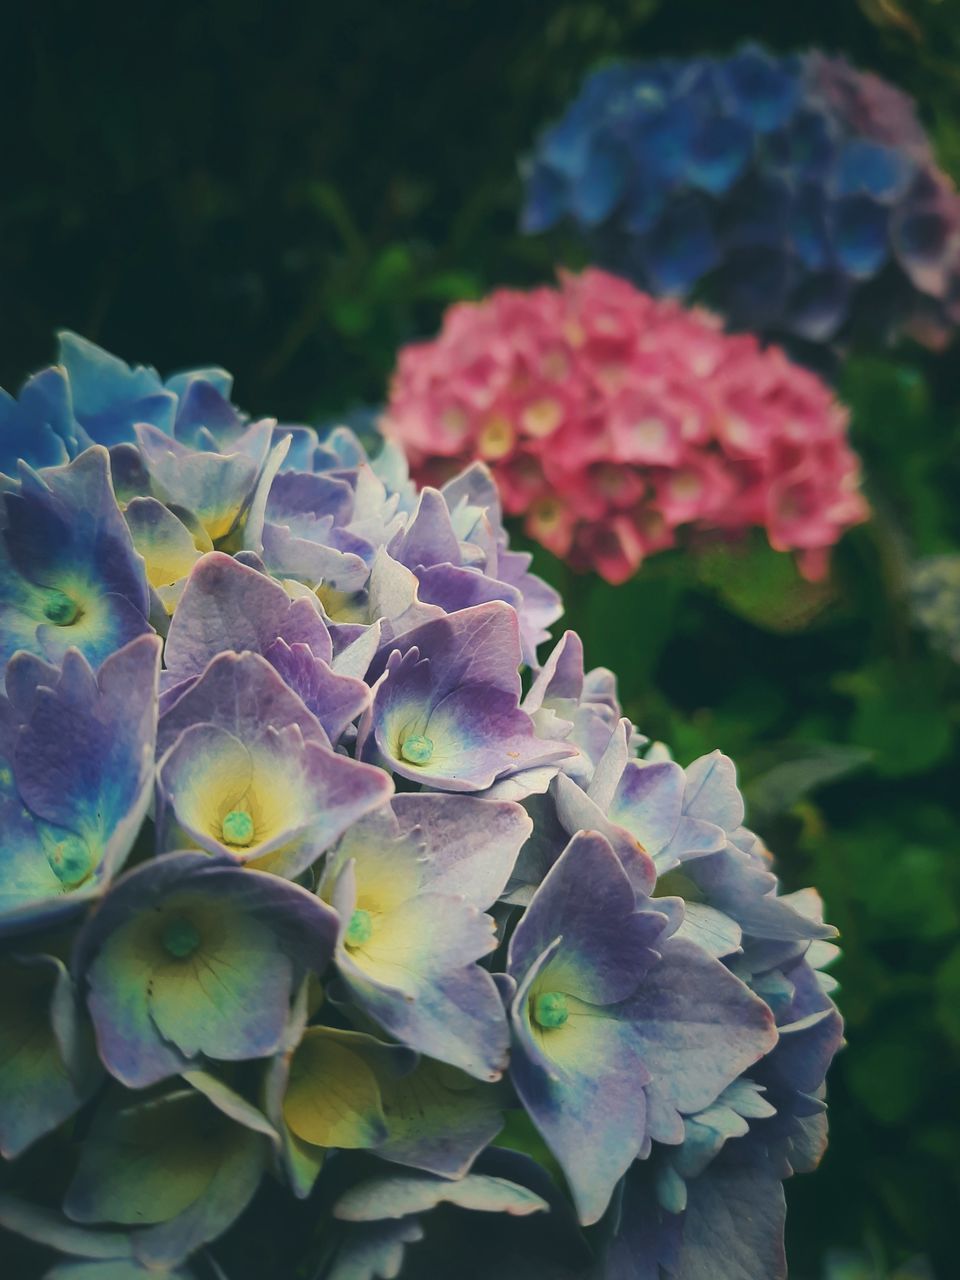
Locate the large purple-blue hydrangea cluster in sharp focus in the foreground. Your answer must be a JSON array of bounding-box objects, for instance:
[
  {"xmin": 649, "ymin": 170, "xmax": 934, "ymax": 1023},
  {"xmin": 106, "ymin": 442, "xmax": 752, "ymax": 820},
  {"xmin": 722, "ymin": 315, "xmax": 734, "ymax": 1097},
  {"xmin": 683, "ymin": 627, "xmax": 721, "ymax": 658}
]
[{"xmin": 0, "ymin": 334, "xmax": 841, "ymax": 1280}]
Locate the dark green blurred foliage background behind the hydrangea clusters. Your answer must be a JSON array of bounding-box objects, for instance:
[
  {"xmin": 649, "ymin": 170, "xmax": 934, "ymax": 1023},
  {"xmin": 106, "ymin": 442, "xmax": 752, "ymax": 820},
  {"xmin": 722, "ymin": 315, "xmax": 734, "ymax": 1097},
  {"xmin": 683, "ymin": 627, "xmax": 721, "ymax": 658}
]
[{"xmin": 0, "ymin": 0, "xmax": 960, "ymax": 1280}]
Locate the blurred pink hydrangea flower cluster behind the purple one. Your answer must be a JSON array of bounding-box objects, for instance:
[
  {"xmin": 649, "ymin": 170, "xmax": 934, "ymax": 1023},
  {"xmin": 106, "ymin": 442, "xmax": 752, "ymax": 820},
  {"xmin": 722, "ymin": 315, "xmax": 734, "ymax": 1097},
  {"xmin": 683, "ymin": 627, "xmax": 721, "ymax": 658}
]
[{"xmin": 384, "ymin": 270, "xmax": 867, "ymax": 582}]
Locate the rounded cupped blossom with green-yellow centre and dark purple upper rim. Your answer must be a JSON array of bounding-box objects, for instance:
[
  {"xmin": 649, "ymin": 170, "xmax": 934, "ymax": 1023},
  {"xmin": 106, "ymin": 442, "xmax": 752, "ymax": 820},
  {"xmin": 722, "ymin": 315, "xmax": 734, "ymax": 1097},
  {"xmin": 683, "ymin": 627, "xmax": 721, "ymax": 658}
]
[{"xmin": 73, "ymin": 854, "xmax": 337, "ymax": 1088}]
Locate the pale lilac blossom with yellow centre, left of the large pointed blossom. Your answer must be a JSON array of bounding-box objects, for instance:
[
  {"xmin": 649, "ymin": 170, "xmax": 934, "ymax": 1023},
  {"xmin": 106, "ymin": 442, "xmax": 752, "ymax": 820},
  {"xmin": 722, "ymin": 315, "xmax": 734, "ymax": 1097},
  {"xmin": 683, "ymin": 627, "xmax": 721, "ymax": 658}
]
[{"xmin": 321, "ymin": 794, "xmax": 531, "ymax": 1080}]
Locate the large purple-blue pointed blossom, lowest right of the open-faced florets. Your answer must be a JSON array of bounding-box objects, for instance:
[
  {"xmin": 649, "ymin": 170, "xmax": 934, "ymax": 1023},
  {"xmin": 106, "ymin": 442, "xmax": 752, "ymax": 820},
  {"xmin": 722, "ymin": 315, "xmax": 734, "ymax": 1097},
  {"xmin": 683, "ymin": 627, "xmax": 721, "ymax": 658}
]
[{"xmin": 507, "ymin": 832, "xmax": 777, "ymax": 1222}]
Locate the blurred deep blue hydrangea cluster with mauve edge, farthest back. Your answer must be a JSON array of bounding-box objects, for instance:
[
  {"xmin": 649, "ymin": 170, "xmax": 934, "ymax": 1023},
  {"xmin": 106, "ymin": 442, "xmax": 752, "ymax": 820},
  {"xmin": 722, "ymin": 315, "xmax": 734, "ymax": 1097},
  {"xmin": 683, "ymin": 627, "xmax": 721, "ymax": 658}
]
[{"xmin": 522, "ymin": 45, "xmax": 960, "ymax": 347}]
